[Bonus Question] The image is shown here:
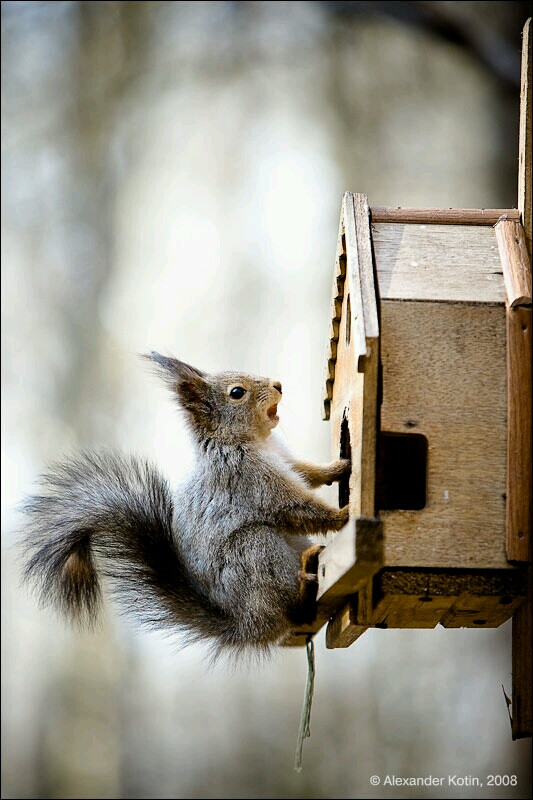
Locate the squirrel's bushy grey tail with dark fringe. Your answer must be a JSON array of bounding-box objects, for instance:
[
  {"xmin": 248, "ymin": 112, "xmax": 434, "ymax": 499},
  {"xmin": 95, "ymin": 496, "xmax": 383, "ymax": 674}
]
[{"xmin": 23, "ymin": 453, "xmax": 227, "ymax": 648}]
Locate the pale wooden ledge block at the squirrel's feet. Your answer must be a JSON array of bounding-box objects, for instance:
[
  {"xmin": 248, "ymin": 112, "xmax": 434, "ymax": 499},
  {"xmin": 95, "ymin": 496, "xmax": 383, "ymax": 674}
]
[{"xmin": 317, "ymin": 517, "xmax": 383, "ymax": 610}]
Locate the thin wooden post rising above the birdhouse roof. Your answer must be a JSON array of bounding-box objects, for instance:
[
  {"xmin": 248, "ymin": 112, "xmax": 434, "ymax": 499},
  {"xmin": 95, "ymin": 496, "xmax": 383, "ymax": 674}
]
[{"xmin": 518, "ymin": 18, "xmax": 533, "ymax": 258}]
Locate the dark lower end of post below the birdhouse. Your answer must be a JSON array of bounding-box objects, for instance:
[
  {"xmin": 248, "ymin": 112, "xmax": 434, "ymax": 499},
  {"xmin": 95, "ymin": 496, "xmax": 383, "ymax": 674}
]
[{"xmin": 512, "ymin": 567, "xmax": 533, "ymax": 739}]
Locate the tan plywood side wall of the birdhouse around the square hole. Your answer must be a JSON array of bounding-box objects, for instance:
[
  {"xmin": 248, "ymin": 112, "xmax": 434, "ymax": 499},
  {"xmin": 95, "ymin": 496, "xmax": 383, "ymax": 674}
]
[{"xmin": 380, "ymin": 301, "xmax": 511, "ymax": 569}]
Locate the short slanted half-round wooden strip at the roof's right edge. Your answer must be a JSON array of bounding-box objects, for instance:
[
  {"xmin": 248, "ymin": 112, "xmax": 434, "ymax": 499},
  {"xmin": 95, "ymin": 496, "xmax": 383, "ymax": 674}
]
[{"xmin": 495, "ymin": 222, "xmax": 531, "ymax": 308}]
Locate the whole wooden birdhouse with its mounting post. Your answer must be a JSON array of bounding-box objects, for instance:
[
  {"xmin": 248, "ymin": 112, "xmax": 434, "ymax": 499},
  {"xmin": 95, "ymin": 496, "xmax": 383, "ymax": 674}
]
[{"xmin": 286, "ymin": 21, "xmax": 533, "ymax": 737}]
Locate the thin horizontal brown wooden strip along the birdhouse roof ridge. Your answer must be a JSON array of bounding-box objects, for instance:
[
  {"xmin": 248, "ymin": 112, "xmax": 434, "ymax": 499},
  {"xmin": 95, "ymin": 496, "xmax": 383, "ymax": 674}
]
[{"xmin": 370, "ymin": 206, "xmax": 520, "ymax": 226}]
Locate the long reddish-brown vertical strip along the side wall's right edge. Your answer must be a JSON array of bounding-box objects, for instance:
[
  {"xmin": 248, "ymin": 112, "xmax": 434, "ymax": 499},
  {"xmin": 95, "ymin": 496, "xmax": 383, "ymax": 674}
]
[{"xmin": 505, "ymin": 307, "xmax": 533, "ymax": 561}]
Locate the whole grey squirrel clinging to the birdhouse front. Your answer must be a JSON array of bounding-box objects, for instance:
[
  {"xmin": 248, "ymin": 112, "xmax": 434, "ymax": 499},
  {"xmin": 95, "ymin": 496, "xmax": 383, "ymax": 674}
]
[{"xmin": 23, "ymin": 352, "xmax": 350, "ymax": 655}]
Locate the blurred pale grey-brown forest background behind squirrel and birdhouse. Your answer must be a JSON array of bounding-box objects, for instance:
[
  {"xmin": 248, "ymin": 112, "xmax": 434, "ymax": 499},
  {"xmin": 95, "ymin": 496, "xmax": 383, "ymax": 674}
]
[{"xmin": 2, "ymin": 2, "xmax": 531, "ymax": 798}]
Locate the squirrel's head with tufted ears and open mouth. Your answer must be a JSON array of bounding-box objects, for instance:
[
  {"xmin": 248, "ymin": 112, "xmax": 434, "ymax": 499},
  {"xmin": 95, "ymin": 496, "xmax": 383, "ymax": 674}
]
[{"xmin": 146, "ymin": 352, "xmax": 281, "ymax": 444}]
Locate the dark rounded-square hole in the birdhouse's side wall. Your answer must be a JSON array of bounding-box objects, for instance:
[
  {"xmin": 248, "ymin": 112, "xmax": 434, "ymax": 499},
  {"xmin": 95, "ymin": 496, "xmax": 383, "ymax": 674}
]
[{"xmin": 376, "ymin": 432, "xmax": 428, "ymax": 511}]
